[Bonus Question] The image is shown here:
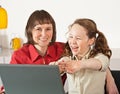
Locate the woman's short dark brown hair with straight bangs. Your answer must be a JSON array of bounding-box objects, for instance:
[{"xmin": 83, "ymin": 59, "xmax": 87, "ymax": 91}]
[{"xmin": 25, "ymin": 10, "xmax": 56, "ymax": 44}]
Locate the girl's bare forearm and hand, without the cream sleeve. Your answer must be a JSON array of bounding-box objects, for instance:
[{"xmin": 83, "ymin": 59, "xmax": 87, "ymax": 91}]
[{"xmin": 59, "ymin": 58, "xmax": 102, "ymax": 73}]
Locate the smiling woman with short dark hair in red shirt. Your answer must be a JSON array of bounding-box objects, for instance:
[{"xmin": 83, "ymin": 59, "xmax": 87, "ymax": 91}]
[{"xmin": 10, "ymin": 10, "xmax": 66, "ymax": 83}]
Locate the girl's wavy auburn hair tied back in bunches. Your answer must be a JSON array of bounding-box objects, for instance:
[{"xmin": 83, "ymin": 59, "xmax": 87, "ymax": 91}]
[{"xmin": 62, "ymin": 18, "xmax": 112, "ymax": 59}]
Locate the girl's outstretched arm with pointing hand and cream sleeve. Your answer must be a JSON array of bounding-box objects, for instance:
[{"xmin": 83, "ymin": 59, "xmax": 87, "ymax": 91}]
[{"xmin": 60, "ymin": 57, "xmax": 109, "ymax": 73}]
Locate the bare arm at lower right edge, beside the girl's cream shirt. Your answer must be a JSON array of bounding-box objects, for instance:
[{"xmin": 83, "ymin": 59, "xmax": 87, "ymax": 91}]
[{"xmin": 106, "ymin": 68, "xmax": 119, "ymax": 94}]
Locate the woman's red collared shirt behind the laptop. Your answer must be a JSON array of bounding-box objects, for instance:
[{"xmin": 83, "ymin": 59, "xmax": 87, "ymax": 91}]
[{"xmin": 10, "ymin": 42, "xmax": 66, "ymax": 84}]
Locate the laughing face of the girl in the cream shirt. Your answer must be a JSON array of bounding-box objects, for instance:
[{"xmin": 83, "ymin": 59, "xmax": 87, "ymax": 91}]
[{"xmin": 68, "ymin": 24, "xmax": 93, "ymax": 57}]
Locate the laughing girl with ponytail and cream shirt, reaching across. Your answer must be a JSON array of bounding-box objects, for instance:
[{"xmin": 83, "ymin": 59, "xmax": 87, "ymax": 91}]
[{"xmin": 52, "ymin": 19, "xmax": 115, "ymax": 94}]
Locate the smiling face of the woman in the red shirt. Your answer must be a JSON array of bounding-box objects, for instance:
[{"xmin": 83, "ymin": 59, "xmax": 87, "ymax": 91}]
[{"xmin": 32, "ymin": 24, "xmax": 53, "ymax": 47}]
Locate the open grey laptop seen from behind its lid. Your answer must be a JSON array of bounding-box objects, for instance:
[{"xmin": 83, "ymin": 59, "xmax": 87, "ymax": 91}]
[{"xmin": 0, "ymin": 64, "xmax": 65, "ymax": 94}]
